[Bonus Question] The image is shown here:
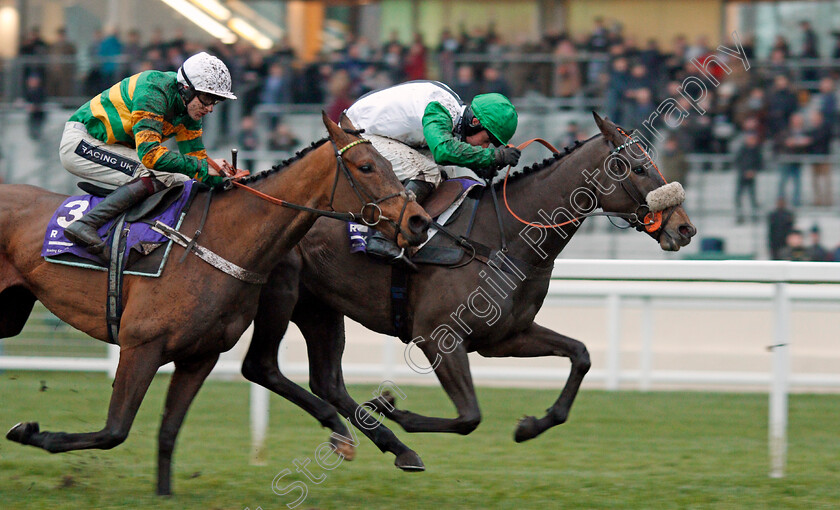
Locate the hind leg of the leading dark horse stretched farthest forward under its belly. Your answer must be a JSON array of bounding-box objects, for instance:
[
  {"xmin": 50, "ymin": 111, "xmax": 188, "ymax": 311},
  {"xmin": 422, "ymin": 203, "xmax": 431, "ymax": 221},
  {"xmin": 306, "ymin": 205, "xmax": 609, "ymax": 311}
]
[{"xmin": 294, "ymin": 295, "xmax": 425, "ymax": 471}]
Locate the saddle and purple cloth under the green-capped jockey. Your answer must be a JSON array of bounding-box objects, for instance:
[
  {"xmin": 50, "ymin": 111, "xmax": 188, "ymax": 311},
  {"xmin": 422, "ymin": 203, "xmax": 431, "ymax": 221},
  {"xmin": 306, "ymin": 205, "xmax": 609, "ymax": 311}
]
[{"xmin": 347, "ymin": 177, "xmax": 484, "ymax": 265}]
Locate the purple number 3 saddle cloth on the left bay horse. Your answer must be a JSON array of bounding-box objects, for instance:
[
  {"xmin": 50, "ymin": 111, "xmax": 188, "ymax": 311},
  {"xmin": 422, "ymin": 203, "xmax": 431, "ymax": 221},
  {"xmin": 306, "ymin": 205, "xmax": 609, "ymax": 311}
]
[{"xmin": 41, "ymin": 181, "xmax": 196, "ymax": 276}]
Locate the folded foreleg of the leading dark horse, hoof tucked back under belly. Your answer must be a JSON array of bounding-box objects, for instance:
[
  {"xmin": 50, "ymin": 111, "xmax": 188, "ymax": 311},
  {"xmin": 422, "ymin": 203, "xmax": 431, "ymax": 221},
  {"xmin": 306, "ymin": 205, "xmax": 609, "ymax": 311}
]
[{"xmin": 368, "ymin": 342, "xmax": 481, "ymax": 435}]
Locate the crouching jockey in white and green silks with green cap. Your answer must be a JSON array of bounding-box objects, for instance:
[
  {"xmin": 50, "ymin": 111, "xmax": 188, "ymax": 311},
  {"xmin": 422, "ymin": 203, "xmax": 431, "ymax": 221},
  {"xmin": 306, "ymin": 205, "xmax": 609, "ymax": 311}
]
[{"xmin": 344, "ymin": 80, "xmax": 520, "ymax": 262}]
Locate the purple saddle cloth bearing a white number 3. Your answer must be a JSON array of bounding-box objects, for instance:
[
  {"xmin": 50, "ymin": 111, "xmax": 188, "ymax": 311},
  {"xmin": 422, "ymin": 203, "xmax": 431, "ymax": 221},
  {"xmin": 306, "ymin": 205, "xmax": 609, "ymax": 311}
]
[{"xmin": 41, "ymin": 181, "xmax": 195, "ymax": 265}]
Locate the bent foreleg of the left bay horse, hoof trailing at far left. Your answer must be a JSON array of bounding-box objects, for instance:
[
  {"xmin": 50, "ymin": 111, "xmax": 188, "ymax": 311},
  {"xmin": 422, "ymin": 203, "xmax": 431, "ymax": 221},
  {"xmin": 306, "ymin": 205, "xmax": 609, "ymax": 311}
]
[{"xmin": 6, "ymin": 342, "xmax": 161, "ymax": 453}]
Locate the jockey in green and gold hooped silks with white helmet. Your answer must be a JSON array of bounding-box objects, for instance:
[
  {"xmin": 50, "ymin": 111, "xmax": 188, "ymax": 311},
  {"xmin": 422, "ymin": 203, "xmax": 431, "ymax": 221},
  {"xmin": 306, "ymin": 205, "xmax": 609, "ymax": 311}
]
[{"xmin": 59, "ymin": 52, "xmax": 246, "ymax": 255}]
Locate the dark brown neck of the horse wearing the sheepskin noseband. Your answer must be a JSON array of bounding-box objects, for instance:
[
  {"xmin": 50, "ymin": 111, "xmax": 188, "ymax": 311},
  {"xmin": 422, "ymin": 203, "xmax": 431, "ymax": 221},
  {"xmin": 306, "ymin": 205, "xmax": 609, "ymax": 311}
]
[{"xmin": 489, "ymin": 140, "xmax": 603, "ymax": 266}]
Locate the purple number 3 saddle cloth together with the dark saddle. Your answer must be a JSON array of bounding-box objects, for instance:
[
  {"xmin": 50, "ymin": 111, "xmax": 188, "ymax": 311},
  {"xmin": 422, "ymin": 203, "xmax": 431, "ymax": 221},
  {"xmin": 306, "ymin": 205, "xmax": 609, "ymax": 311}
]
[{"xmin": 41, "ymin": 181, "xmax": 199, "ymax": 277}]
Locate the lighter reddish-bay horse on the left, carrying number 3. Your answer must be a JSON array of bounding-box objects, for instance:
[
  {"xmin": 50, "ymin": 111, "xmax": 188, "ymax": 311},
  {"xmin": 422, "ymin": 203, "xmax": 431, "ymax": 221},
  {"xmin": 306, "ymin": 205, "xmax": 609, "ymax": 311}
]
[{"xmin": 0, "ymin": 114, "xmax": 431, "ymax": 494}]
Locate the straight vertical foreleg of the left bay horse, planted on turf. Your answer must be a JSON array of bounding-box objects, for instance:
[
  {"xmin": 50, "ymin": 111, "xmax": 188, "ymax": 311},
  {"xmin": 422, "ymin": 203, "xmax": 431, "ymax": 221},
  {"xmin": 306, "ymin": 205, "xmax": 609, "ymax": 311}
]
[{"xmin": 157, "ymin": 353, "xmax": 219, "ymax": 496}]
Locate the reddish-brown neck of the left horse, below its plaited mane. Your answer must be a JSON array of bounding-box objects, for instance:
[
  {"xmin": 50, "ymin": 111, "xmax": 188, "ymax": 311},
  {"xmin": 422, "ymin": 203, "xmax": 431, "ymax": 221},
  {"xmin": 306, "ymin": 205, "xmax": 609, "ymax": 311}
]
[{"xmin": 218, "ymin": 142, "xmax": 337, "ymax": 271}]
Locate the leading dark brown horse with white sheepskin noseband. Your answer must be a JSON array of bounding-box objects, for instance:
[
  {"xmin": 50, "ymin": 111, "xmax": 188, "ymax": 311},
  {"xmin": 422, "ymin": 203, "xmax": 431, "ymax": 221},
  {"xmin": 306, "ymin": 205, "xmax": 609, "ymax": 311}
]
[{"xmin": 242, "ymin": 112, "xmax": 696, "ymax": 471}]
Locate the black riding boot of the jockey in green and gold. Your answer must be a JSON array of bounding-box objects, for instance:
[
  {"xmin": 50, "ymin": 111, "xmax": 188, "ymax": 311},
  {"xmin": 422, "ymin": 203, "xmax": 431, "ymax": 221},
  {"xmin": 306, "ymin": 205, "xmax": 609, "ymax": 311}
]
[{"xmin": 64, "ymin": 177, "xmax": 163, "ymax": 256}]
